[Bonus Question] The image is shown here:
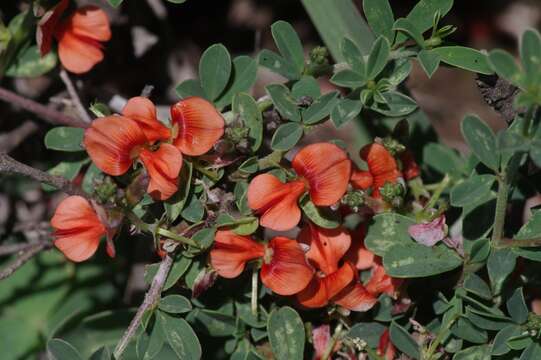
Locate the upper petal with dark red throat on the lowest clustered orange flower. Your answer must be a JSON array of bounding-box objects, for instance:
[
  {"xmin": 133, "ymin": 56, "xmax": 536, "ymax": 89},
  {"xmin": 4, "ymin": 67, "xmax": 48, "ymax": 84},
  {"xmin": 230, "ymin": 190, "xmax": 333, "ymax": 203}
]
[{"xmin": 298, "ymin": 223, "xmax": 351, "ymax": 274}]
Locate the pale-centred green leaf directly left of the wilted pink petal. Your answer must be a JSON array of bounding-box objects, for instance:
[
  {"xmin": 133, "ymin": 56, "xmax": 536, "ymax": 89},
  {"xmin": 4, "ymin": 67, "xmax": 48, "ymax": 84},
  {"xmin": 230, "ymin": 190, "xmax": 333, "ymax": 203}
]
[{"xmin": 364, "ymin": 213, "xmax": 415, "ymax": 256}]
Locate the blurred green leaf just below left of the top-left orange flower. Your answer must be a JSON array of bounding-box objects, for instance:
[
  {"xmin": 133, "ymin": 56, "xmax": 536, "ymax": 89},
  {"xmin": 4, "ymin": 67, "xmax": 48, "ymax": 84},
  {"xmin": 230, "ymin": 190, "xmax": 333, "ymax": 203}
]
[{"xmin": 6, "ymin": 45, "xmax": 57, "ymax": 78}]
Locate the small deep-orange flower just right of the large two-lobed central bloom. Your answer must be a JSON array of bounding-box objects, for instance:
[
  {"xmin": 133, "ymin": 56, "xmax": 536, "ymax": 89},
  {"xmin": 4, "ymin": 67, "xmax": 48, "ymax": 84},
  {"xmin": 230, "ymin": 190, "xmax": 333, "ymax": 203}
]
[{"xmin": 351, "ymin": 143, "xmax": 402, "ymax": 199}]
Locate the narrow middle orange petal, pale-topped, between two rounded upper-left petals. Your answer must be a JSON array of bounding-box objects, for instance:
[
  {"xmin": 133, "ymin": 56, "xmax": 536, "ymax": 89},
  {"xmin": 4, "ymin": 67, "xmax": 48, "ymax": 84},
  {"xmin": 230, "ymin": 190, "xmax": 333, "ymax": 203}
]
[{"xmin": 122, "ymin": 96, "xmax": 171, "ymax": 142}]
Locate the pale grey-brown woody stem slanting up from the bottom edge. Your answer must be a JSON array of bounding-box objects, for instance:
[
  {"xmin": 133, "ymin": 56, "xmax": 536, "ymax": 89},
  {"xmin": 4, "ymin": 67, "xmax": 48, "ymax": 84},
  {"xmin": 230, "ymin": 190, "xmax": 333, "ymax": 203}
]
[{"xmin": 113, "ymin": 254, "xmax": 173, "ymax": 359}]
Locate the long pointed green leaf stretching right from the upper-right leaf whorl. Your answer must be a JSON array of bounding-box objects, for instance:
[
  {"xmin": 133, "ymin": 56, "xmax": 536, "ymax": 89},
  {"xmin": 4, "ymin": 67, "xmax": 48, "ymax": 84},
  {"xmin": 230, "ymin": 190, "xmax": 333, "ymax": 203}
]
[{"xmin": 431, "ymin": 46, "xmax": 493, "ymax": 75}]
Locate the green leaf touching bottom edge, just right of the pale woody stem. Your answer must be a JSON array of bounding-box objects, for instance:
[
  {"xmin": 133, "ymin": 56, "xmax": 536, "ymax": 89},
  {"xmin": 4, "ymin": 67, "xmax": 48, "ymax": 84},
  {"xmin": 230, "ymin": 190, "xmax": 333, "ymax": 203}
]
[{"xmin": 161, "ymin": 311, "xmax": 202, "ymax": 360}]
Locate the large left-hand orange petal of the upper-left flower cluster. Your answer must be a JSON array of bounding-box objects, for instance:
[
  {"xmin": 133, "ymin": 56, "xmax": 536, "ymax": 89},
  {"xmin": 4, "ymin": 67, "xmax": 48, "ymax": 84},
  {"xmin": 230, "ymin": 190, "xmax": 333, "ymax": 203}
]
[{"xmin": 83, "ymin": 115, "xmax": 147, "ymax": 176}]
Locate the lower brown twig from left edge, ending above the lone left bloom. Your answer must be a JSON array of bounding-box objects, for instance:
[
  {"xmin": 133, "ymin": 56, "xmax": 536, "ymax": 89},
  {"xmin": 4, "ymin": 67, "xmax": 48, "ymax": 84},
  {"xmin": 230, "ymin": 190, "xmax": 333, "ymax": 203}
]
[{"xmin": 0, "ymin": 153, "xmax": 85, "ymax": 196}]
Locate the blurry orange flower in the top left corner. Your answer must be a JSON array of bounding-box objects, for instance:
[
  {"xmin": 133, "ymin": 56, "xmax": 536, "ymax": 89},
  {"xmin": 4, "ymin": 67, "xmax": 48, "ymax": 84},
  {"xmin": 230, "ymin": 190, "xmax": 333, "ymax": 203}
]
[{"xmin": 52, "ymin": 3, "xmax": 111, "ymax": 74}]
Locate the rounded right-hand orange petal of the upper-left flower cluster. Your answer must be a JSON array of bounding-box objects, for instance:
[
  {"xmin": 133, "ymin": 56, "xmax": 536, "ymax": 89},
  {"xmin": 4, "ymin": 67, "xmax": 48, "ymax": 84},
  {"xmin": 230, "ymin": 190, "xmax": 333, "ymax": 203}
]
[{"xmin": 171, "ymin": 96, "xmax": 225, "ymax": 156}]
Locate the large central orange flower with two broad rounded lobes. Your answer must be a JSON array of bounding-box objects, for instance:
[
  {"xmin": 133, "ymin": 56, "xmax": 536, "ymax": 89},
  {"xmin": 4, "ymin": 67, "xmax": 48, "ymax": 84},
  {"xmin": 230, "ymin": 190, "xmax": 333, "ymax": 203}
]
[{"xmin": 247, "ymin": 143, "xmax": 351, "ymax": 231}]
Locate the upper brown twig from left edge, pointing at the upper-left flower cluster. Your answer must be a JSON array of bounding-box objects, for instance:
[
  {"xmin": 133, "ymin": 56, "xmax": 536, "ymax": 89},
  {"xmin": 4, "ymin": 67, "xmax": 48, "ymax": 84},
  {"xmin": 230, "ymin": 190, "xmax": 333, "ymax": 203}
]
[{"xmin": 0, "ymin": 87, "xmax": 89, "ymax": 128}]
